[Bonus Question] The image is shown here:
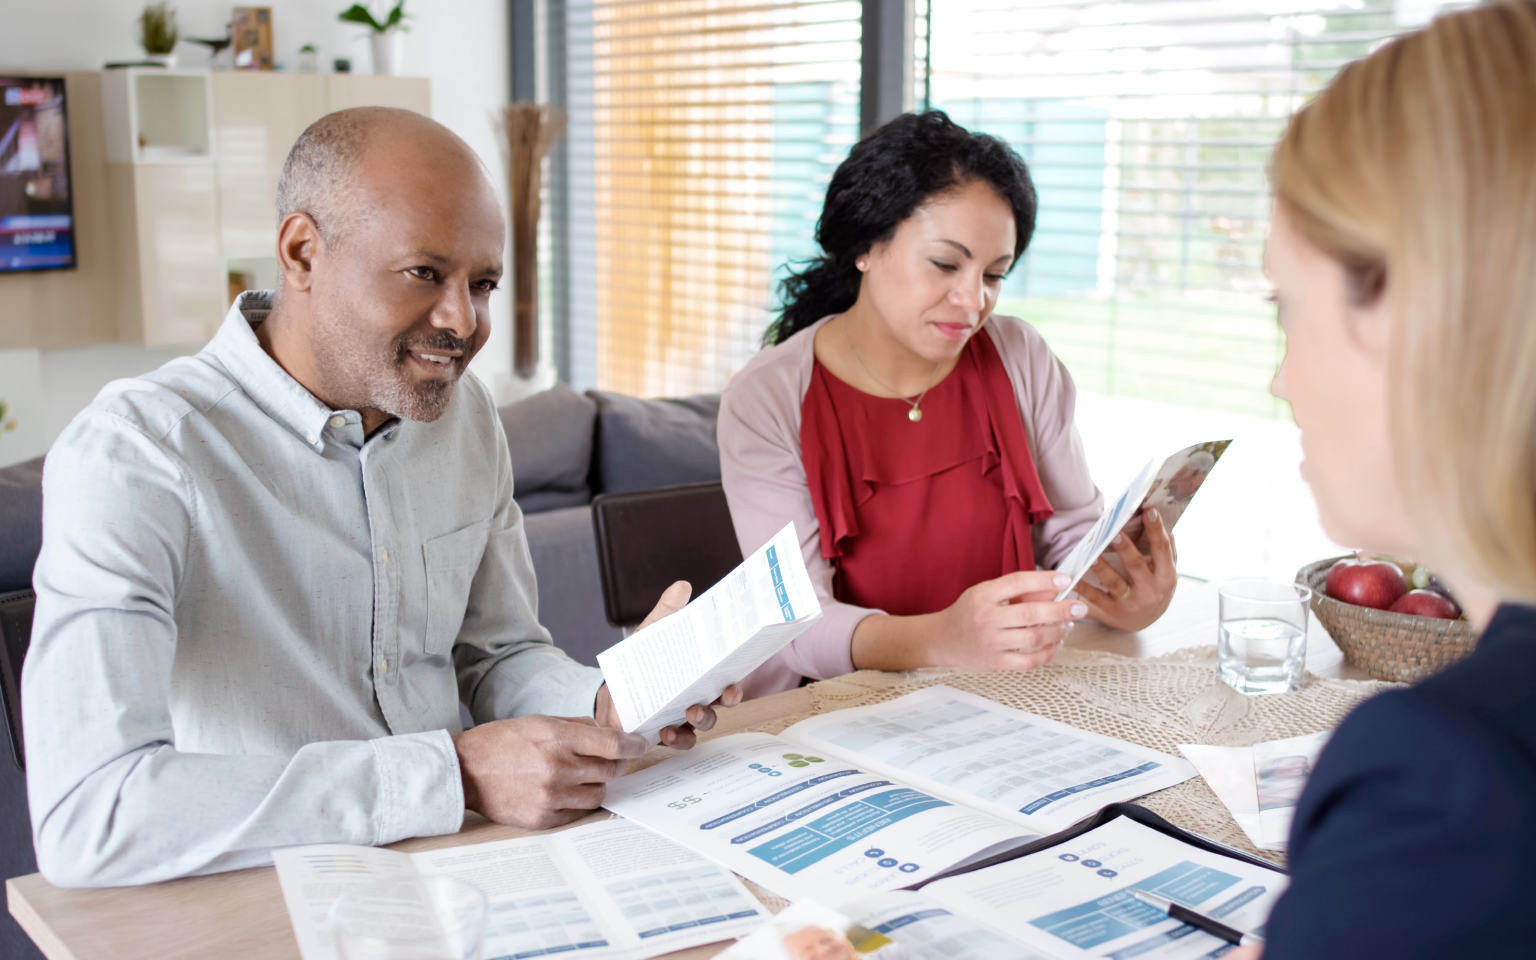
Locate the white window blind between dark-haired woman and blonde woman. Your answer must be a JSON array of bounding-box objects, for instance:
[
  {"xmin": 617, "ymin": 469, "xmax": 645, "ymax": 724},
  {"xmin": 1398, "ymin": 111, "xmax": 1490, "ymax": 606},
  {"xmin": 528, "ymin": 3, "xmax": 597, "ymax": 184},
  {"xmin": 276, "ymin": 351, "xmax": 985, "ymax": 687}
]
[{"xmin": 914, "ymin": 0, "xmax": 1468, "ymax": 416}]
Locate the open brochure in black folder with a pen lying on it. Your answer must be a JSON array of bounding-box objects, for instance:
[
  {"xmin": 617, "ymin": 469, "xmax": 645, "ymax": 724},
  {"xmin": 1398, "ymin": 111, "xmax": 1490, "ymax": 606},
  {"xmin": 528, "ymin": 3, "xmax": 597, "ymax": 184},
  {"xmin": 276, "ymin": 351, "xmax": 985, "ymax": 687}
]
[{"xmin": 720, "ymin": 817, "xmax": 1287, "ymax": 960}]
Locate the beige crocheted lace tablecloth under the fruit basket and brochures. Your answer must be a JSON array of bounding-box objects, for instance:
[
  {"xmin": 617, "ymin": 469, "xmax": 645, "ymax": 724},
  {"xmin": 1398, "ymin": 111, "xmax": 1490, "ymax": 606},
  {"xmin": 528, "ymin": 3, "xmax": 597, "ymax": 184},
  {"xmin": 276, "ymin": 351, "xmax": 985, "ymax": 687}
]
[{"xmin": 737, "ymin": 647, "xmax": 1396, "ymax": 863}]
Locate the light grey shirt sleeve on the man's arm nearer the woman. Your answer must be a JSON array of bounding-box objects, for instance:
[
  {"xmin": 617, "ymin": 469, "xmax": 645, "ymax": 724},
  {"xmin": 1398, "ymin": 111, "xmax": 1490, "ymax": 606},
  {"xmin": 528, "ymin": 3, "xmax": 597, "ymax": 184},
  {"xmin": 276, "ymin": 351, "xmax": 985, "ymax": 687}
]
[{"xmin": 453, "ymin": 413, "xmax": 602, "ymax": 723}]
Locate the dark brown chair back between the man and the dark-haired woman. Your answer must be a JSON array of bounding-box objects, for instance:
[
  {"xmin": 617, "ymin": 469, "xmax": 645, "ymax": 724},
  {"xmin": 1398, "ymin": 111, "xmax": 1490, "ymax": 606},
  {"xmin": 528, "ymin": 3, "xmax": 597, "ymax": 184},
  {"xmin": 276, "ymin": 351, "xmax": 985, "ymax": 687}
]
[{"xmin": 591, "ymin": 481, "xmax": 742, "ymax": 627}]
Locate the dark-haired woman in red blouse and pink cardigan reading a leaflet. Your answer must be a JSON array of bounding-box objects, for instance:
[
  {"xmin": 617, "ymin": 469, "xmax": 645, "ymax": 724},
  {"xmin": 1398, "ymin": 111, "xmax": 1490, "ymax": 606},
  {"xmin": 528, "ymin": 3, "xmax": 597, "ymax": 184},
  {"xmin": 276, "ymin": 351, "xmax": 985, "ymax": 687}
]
[{"xmin": 719, "ymin": 112, "xmax": 1175, "ymax": 696}]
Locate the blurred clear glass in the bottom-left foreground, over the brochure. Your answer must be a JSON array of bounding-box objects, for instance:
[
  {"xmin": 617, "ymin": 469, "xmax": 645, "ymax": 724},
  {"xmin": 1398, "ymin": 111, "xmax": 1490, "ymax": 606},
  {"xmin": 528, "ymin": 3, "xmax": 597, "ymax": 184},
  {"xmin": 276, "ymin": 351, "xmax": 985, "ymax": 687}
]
[{"xmin": 330, "ymin": 877, "xmax": 487, "ymax": 960}]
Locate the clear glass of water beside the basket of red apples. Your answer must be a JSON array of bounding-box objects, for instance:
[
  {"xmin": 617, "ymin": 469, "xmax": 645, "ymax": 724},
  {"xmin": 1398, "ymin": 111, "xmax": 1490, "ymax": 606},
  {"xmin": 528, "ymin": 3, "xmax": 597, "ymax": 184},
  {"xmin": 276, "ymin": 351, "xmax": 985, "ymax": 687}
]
[{"xmin": 1217, "ymin": 581, "xmax": 1312, "ymax": 694}]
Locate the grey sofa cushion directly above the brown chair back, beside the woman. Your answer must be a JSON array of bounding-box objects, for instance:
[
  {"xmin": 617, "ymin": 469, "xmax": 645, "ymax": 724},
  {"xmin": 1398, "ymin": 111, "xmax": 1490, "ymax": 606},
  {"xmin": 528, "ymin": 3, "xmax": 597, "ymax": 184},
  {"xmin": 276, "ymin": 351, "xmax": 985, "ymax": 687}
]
[{"xmin": 587, "ymin": 390, "xmax": 720, "ymax": 493}]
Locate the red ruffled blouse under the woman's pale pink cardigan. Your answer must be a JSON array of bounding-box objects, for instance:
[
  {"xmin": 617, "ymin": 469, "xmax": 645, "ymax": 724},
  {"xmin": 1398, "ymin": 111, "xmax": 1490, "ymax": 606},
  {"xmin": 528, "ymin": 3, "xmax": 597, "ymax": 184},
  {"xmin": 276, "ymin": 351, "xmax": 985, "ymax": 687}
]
[{"xmin": 800, "ymin": 333, "xmax": 1052, "ymax": 616}]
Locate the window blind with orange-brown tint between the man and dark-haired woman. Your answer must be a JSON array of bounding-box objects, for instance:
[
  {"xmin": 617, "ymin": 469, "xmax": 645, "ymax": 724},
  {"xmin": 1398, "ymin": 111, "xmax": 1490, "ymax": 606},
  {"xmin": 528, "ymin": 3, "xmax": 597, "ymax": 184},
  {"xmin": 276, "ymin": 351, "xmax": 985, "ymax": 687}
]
[{"xmin": 559, "ymin": 0, "xmax": 862, "ymax": 396}]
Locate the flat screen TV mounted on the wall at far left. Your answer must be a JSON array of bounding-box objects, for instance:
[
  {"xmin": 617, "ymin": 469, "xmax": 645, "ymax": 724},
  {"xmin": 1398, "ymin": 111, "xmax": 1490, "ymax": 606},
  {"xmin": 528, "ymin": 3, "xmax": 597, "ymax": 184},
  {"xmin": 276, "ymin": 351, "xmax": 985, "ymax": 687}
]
[{"xmin": 0, "ymin": 77, "xmax": 75, "ymax": 272}]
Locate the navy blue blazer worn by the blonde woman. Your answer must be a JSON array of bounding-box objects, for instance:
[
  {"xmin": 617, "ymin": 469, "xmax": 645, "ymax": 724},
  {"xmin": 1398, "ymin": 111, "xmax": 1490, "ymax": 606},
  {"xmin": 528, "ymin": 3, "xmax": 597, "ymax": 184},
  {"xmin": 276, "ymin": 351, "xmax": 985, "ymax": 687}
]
[{"xmin": 1264, "ymin": 605, "xmax": 1536, "ymax": 960}]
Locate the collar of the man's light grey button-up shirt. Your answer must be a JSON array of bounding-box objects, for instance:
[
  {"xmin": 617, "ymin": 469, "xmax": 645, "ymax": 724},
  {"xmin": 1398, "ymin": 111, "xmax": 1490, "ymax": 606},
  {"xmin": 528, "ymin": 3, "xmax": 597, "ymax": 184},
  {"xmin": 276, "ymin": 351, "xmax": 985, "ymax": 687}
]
[{"xmin": 206, "ymin": 290, "xmax": 390, "ymax": 453}]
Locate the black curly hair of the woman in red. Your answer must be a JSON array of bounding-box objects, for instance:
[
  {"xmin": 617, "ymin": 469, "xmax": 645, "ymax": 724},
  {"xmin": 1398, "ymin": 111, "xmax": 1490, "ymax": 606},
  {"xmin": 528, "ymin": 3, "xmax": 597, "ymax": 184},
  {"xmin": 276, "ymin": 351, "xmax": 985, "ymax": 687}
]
[{"xmin": 763, "ymin": 111, "xmax": 1035, "ymax": 346}]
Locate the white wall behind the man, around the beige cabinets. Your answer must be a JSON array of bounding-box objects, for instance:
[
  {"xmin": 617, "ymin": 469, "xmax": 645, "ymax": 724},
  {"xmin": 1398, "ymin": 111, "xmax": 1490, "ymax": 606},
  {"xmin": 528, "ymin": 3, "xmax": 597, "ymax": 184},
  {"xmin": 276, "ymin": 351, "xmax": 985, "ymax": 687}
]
[{"xmin": 0, "ymin": 0, "xmax": 548, "ymax": 467}]
